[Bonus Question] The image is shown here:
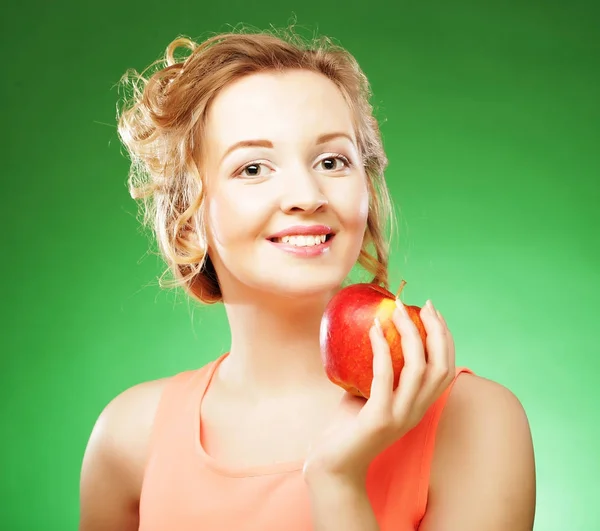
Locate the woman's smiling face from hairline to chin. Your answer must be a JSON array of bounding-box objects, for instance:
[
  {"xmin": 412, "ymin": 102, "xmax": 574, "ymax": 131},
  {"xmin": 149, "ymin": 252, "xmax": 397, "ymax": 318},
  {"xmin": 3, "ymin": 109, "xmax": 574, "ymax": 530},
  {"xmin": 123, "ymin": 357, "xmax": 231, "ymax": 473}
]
[{"xmin": 202, "ymin": 71, "xmax": 369, "ymax": 302}]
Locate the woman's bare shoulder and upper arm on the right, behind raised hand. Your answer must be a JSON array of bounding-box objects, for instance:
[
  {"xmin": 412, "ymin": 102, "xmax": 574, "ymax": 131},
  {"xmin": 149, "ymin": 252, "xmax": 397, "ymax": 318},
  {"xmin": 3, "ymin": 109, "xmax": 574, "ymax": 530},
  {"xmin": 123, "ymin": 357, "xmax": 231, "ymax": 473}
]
[{"xmin": 420, "ymin": 373, "xmax": 536, "ymax": 531}]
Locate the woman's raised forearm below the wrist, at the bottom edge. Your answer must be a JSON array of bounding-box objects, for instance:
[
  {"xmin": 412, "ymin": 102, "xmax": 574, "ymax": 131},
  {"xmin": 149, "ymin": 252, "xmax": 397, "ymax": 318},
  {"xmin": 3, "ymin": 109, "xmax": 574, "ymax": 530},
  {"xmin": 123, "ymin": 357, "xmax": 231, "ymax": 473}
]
[{"xmin": 307, "ymin": 477, "xmax": 379, "ymax": 531}]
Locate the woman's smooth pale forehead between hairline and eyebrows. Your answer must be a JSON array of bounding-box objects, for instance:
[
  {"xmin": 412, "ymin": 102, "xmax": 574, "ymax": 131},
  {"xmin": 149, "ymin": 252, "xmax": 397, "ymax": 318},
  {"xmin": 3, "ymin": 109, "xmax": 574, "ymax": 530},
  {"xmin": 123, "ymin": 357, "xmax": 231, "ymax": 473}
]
[{"xmin": 206, "ymin": 70, "xmax": 354, "ymax": 151}]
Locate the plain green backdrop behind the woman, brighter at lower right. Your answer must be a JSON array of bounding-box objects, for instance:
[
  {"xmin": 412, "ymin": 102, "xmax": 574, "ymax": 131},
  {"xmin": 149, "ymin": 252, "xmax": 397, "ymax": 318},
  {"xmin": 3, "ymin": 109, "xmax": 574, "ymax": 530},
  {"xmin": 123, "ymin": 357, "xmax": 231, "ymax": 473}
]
[{"xmin": 0, "ymin": 0, "xmax": 600, "ymax": 531}]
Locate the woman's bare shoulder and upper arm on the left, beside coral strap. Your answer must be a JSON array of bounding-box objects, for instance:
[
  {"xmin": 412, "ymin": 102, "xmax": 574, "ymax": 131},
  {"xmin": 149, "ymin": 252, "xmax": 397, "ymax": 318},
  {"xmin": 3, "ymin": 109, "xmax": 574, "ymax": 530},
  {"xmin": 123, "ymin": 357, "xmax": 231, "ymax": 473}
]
[{"xmin": 79, "ymin": 378, "xmax": 170, "ymax": 531}]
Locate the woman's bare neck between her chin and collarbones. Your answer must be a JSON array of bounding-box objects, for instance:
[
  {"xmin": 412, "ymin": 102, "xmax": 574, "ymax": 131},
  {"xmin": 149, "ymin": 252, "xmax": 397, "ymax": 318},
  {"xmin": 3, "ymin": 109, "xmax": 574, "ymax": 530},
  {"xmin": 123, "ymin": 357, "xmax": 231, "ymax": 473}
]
[{"xmin": 220, "ymin": 286, "xmax": 340, "ymax": 395}]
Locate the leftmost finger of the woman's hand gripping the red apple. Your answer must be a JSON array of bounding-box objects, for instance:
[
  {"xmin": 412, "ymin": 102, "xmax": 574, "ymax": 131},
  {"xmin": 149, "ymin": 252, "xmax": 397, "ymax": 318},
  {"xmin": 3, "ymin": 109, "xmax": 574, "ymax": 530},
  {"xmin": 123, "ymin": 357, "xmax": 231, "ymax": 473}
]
[{"xmin": 369, "ymin": 318, "xmax": 394, "ymax": 409}]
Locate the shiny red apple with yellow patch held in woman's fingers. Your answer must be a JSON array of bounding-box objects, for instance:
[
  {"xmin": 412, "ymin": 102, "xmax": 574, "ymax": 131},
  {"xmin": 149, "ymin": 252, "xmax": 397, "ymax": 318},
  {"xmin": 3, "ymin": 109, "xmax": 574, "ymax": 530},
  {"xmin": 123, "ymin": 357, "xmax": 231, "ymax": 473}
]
[{"xmin": 320, "ymin": 281, "xmax": 427, "ymax": 399}]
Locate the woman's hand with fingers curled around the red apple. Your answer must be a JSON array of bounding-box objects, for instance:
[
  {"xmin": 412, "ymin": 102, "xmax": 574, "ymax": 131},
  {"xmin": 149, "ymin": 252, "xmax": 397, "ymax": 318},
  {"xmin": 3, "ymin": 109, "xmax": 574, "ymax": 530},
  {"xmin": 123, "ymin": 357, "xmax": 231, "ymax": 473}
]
[{"xmin": 304, "ymin": 300, "xmax": 455, "ymax": 482}]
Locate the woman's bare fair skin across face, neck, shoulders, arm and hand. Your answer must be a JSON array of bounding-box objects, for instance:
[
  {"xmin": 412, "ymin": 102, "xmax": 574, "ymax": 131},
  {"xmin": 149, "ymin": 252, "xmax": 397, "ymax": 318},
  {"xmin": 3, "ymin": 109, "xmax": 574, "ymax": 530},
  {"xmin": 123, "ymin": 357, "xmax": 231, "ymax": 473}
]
[{"xmin": 79, "ymin": 71, "xmax": 535, "ymax": 531}]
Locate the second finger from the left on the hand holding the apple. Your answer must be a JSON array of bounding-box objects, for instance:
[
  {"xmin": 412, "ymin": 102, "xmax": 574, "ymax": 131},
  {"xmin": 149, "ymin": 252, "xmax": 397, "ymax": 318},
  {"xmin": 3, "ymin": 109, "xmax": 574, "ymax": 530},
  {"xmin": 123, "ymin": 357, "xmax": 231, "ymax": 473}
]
[{"xmin": 392, "ymin": 299, "xmax": 426, "ymax": 421}]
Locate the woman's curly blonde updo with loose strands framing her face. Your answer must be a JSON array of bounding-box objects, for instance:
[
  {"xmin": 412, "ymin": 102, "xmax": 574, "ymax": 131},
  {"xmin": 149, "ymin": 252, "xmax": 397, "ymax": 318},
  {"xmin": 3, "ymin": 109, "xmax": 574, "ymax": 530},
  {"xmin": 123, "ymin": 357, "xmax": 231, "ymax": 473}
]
[{"xmin": 117, "ymin": 29, "xmax": 393, "ymax": 304}]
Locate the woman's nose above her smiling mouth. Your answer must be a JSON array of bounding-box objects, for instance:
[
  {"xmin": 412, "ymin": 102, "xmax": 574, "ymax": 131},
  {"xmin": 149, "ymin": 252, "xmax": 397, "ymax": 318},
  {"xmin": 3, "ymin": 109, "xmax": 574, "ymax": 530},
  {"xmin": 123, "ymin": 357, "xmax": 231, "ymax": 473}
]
[{"xmin": 281, "ymin": 170, "xmax": 329, "ymax": 214}]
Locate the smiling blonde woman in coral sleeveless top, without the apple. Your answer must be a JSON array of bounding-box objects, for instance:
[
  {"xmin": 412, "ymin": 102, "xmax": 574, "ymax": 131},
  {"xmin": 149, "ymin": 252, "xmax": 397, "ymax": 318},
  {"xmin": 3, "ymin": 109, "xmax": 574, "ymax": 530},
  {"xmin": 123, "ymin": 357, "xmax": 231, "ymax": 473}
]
[{"xmin": 80, "ymin": 30, "xmax": 535, "ymax": 531}]
